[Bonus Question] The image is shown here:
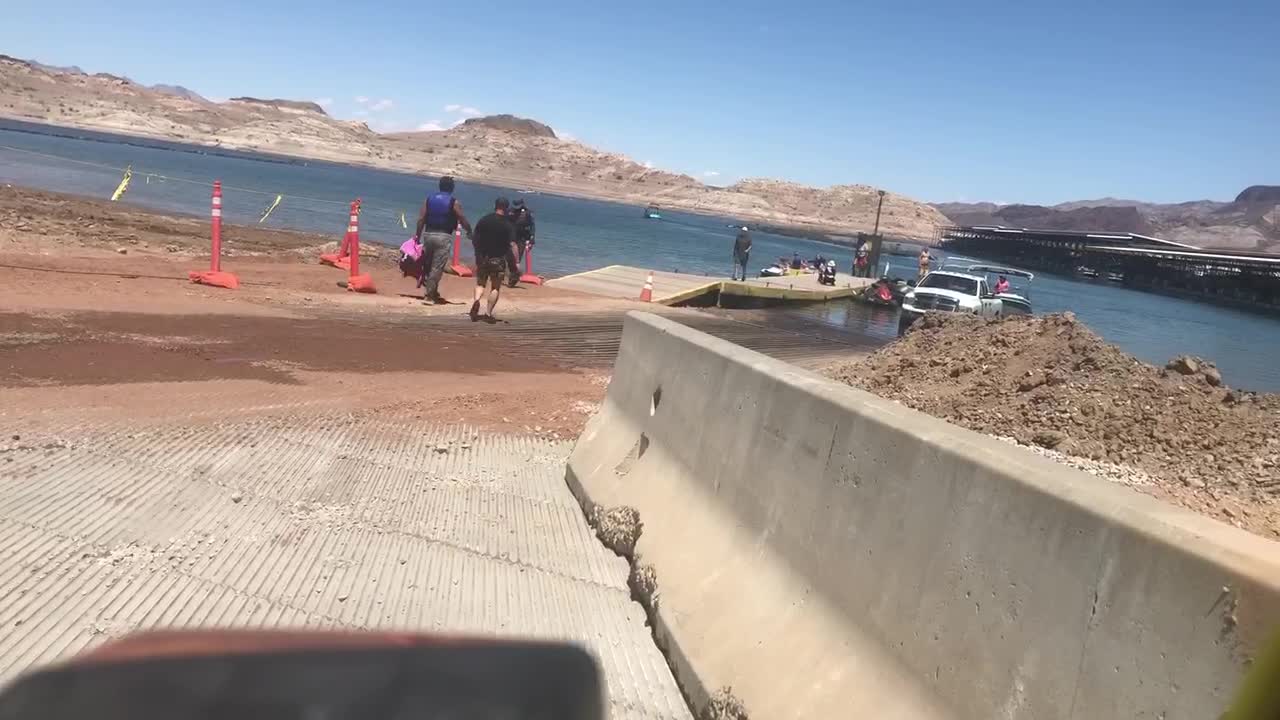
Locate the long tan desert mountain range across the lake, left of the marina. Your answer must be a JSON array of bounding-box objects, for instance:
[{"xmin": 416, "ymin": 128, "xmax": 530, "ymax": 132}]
[{"xmin": 0, "ymin": 55, "xmax": 947, "ymax": 240}]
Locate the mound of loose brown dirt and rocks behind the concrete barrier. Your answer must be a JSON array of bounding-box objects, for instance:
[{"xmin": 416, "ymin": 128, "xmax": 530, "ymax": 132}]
[{"xmin": 827, "ymin": 313, "xmax": 1280, "ymax": 538}]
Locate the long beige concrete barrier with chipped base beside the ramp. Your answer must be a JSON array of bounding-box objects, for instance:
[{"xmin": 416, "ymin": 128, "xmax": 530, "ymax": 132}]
[{"xmin": 568, "ymin": 313, "xmax": 1280, "ymax": 720}]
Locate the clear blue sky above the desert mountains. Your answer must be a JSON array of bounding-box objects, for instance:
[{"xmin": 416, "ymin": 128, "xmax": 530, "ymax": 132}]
[{"xmin": 0, "ymin": 0, "xmax": 1280, "ymax": 204}]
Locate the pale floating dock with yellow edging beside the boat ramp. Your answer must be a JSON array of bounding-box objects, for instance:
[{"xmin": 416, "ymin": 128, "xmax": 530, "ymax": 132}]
[{"xmin": 547, "ymin": 265, "xmax": 873, "ymax": 305}]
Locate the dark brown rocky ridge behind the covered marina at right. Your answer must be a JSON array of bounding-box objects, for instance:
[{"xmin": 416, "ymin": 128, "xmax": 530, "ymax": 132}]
[{"xmin": 933, "ymin": 190, "xmax": 1280, "ymax": 254}]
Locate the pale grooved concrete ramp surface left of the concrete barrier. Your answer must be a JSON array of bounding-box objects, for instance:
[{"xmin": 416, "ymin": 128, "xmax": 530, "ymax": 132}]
[{"xmin": 0, "ymin": 411, "xmax": 690, "ymax": 719}]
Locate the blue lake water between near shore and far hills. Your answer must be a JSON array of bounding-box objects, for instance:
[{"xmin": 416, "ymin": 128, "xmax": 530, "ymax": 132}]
[{"xmin": 0, "ymin": 120, "xmax": 1280, "ymax": 391}]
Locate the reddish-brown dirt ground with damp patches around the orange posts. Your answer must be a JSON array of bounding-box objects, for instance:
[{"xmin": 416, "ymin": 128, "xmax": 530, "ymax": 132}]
[{"xmin": 0, "ymin": 187, "xmax": 619, "ymax": 437}]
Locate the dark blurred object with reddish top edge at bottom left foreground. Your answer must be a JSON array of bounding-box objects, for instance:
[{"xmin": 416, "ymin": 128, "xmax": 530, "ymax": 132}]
[{"xmin": 0, "ymin": 630, "xmax": 605, "ymax": 720}]
